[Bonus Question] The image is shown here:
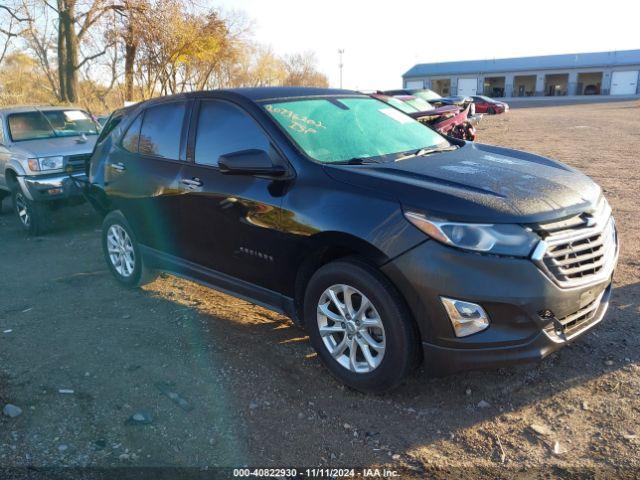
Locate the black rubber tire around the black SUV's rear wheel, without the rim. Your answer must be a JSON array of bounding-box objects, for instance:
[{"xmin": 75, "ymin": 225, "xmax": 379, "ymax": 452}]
[{"xmin": 102, "ymin": 210, "xmax": 158, "ymax": 288}]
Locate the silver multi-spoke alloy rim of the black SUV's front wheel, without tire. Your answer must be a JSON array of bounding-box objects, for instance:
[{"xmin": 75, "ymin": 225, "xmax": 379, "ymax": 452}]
[{"xmin": 317, "ymin": 284, "xmax": 386, "ymax": 373}]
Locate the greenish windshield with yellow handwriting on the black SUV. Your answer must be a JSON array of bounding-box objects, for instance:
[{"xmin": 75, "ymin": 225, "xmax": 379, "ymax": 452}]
[{"xmin": 265, "ymin": 97, "xmax": 449, "ymax": 163}]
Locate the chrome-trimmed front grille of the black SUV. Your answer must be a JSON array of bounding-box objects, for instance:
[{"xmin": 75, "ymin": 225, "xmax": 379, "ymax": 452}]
[{"xmin": 539, "ymin": 200, "xmax": 617, "ymax": 286}]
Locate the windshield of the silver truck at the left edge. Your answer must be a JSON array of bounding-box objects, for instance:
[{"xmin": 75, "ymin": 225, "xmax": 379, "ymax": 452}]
[{"xmin": 8, "ymin": 110, "xmax": 98, "ymax": 142}]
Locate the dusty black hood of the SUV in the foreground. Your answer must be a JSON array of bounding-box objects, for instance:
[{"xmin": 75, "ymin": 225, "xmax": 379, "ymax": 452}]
[{"xmin": 326, "ymin": 142, "xmax": 601, "ymax": 223}]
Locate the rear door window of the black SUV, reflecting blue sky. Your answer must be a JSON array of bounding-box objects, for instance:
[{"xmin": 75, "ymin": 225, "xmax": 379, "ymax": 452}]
[{"xmin": 138, "ymin": 102, "xmax": 187, "ymax": 160}]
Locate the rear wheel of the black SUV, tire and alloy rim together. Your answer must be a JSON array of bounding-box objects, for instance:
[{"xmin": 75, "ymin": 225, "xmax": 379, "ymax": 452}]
[{"xmin": 102, "ymin": 210, "xmax": 158, "ymax": 288}]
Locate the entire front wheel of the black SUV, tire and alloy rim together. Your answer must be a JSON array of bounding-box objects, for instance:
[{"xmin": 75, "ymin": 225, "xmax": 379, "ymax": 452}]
[{"xmin": 304, "ymin": 258, "xmax": 420, "ymax": 393}]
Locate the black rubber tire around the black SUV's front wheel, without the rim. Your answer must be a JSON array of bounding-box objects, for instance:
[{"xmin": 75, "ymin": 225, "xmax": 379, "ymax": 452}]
[{"xmin": 304, "ymin": 257, "xmax": 420, "ymax": 393}]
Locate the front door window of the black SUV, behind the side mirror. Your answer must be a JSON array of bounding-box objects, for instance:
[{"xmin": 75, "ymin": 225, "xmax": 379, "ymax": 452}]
[{"xmin": 195, "ymin": 100, "xmax": 269, "ymax": 166}]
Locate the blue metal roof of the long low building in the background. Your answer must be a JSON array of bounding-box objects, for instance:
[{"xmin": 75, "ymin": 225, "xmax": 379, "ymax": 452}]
[{"xmin": 403, "ymin": 50, "xmax": 640, "ymax": 77}]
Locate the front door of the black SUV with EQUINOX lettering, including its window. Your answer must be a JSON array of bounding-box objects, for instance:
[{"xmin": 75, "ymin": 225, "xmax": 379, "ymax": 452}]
[{"xmin": 175, "ymin": 99, "xmax": 283, "ymax": 289}]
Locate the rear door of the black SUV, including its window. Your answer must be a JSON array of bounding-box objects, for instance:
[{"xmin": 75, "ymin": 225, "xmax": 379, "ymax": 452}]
[{"xmin": 105, "ymin": 100, "xmax": 191, "ymax": 253}]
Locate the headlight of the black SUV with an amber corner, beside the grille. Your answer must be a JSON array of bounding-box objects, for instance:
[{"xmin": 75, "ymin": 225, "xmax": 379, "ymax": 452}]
[{"xmin": 405, "ymin": 212, "xmax": 540, "ymax": 257}]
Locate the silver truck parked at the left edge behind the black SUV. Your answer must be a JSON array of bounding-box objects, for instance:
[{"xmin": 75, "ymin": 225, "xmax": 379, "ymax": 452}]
[{"xmin": 0, "ymin": 106, "xmax": 100, "ymax": 235}]
